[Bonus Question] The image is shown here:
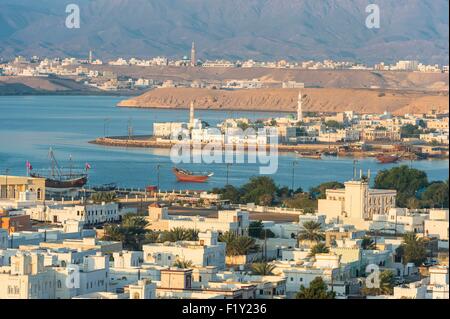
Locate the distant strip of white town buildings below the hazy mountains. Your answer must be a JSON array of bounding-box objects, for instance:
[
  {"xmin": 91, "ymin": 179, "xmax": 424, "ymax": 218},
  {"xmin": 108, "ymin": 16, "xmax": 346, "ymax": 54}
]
[{"xmin": 0, "ymin": 43, "xmax": 449, "ymax": 92}]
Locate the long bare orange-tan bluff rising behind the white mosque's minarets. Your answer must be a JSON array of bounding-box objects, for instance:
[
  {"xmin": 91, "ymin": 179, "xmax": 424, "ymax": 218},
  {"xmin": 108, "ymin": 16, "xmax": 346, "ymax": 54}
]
[{"xmin": 118, "ymin": 88, "xmax": 449, "ymax": 114}]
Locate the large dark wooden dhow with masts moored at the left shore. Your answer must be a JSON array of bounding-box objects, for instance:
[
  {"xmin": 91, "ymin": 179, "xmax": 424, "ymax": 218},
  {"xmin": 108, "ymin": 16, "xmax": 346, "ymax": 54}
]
[{"xmin": 28, "ymin": 149, "xmax": 90, "ymax": 193}]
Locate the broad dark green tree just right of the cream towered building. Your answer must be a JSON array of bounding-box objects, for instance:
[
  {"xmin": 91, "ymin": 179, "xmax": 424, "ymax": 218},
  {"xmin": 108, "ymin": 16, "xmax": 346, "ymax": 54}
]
[{"xmin": 375, "ymin": 165, "xmax": 428, "ymax": 207}]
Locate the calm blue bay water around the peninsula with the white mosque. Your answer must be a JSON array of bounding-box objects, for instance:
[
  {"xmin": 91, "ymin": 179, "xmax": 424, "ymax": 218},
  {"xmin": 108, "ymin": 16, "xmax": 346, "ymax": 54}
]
[{"xmin": 0, "ymin": 96, "xmax": 449, "ymax": 190}]
